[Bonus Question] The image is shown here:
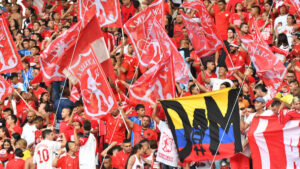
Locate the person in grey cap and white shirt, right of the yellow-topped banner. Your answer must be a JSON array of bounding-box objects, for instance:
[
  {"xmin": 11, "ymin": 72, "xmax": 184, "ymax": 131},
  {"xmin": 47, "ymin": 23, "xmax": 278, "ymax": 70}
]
[{"xmin": 241, "ymin": 97, "xmax": 274, "ymax": 131}]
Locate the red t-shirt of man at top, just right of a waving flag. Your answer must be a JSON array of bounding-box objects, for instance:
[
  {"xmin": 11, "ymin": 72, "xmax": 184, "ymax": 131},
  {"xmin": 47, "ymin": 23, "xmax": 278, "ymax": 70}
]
[{"xmin": 215, "ymin": 11, "xmax": 231, "ymax": 40}]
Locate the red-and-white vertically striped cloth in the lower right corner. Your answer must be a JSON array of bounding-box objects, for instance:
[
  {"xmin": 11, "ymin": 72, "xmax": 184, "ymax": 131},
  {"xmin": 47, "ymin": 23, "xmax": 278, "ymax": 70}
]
[{"xmin": 248, "ymin": 116, "xmax": 300, "ymax": 169}]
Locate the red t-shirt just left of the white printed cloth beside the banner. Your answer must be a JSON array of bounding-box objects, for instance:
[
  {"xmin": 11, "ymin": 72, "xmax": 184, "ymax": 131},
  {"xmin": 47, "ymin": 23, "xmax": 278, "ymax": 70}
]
[{"xmin": 132, "ymin": 123, "xmax": 157, "ymax": 144}]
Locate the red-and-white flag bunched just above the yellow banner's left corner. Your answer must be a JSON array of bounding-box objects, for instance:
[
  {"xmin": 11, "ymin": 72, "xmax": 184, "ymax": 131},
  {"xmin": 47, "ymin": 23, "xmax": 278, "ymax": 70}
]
[{"xmin": 129, "ymin": 57, "xmax": 175, "ymax": 104}]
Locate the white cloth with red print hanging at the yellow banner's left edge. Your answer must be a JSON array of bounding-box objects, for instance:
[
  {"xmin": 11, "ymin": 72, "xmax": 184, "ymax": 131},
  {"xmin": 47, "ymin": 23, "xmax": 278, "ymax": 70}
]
[{"xmin": 156, "ymin": 121, "xmax": 178, "ymax": 167}]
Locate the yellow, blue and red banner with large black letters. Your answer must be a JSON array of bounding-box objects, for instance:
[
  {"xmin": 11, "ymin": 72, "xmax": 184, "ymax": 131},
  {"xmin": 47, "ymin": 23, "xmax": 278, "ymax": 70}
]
[{"xmin": 161, "ymin": 88, "xmax": 242, "ymax": 162}]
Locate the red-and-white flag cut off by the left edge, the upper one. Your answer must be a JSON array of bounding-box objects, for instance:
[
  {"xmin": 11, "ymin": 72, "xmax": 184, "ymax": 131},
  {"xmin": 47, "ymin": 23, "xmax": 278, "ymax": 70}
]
[{"xmin": 0, "ymin": 15, "xmax": 23, "ymax": 74}]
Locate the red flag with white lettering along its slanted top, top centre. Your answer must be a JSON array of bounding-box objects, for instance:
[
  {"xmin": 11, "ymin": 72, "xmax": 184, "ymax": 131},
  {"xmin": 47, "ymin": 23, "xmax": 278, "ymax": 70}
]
[{"xmin": 124, "ymin": 0, "xmax": 164, "ymax": 72}]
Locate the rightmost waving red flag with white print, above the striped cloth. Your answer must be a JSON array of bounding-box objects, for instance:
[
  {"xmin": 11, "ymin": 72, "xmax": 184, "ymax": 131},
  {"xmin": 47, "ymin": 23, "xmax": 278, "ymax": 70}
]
[{"xmin": 239, "ymin": 24, "xmax": 286, "ymax": 92}]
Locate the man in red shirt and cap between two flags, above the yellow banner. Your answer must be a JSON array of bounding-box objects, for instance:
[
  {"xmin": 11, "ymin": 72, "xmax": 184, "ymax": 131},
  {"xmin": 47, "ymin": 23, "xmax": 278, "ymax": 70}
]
[{"xmin": 225, "ymin": 40, "xmax": 250, "ymax": 80}]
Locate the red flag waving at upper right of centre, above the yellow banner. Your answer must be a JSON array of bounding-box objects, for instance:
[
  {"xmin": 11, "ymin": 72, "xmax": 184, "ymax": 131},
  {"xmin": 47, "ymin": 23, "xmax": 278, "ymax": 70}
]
[{"xmin": 181, "ymin": 13, "xmax": 223, "ymax": 57}]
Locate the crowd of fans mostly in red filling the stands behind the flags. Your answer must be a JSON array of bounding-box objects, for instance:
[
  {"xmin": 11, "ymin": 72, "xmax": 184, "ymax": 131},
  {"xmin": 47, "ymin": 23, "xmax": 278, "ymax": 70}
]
[{"xmin": 0, "ymin": 0, "xmax": 300, "ymax": 169}]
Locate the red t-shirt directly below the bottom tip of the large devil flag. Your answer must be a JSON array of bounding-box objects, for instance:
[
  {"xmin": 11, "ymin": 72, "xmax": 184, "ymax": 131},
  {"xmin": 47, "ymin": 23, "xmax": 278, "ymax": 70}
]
[{"xmin": 101, "ymin": 113, "xmax": 126, "ymax": 144}]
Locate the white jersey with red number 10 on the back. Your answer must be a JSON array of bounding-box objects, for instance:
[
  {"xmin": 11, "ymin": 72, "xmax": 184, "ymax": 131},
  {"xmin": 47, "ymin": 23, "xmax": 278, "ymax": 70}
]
[{"xmin": 33, "ymin": 140, "xmax": 61, "ymax": 169}]
